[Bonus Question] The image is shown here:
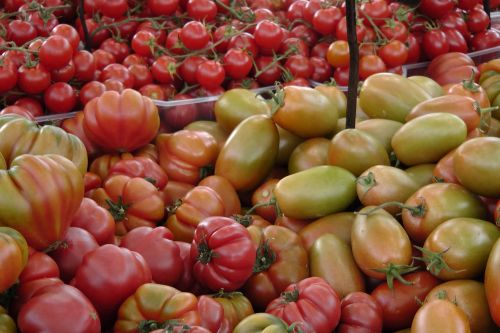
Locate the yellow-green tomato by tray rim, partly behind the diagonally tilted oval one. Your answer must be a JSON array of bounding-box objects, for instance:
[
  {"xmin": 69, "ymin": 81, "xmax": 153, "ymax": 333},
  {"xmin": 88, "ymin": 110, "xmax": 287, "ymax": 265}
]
[{"xmin": 214, "ymin": 88, "xmax": 270, "ymax": 133}]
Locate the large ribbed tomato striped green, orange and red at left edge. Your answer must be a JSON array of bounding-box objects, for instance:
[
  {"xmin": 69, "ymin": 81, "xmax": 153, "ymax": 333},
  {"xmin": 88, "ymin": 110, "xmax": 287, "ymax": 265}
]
[{"xmin": 0, "ymin": 154, "xmax": 83, "ymax": 250}]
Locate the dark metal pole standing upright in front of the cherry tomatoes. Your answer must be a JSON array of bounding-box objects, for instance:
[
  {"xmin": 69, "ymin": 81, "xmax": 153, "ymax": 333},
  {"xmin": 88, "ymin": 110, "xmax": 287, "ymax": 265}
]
[{"xmin": 346, "ymin": 0, "xmax": 359, "ymax": 128}]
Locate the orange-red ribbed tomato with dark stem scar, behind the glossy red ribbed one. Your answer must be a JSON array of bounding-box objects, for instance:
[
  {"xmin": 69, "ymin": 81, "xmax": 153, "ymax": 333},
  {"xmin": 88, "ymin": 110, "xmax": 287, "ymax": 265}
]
[{"xmin": 243, "ymin": 226, "xmax": 309, "ymax": 310}]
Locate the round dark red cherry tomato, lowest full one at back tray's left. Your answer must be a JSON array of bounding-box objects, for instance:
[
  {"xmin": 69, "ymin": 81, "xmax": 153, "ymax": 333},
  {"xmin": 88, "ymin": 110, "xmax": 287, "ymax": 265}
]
[{"xmin": 43, "ymin": 82, "xmax": 77, "ymax": 113}]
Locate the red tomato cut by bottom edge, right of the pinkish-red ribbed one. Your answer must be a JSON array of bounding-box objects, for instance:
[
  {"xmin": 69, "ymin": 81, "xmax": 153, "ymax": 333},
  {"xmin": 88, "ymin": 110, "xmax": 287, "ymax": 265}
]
[{"xmin": 337, "ymin": 291, "xmax": 382, "ymax": 333}]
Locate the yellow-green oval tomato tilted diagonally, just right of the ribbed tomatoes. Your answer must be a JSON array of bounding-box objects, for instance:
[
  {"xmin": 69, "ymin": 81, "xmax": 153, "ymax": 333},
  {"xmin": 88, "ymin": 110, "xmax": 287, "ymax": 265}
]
[{"xmin": 215, "ymin": 115, "xmax": 279, "ymax": 191}]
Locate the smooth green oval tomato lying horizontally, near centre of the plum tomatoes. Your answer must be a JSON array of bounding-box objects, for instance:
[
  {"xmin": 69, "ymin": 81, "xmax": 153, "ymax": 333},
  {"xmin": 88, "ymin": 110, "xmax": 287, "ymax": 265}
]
[{"xmin": 274, "ymin": 165, "xmax": 356, "ymax": 219}]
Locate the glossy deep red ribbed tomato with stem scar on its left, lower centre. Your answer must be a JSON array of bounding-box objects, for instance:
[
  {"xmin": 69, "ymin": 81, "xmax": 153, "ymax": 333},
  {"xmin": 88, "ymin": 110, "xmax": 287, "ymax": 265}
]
[{"xmin": 191, "ymin": 216, "xmax": 256, "ymax": 291}]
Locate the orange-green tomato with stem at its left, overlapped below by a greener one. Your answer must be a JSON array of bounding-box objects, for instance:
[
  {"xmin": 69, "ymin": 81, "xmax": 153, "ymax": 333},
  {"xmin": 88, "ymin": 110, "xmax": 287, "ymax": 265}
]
[{"xmin": 402, "ymin": 183, "xmax": 487, "ymax": 245}]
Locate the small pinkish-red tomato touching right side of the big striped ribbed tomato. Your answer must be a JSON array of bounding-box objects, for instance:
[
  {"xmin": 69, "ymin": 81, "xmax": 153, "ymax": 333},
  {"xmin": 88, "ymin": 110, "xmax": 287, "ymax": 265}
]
[{"xmin": 71, "ymin": 198, "xmax": 115, "ymax": 245}]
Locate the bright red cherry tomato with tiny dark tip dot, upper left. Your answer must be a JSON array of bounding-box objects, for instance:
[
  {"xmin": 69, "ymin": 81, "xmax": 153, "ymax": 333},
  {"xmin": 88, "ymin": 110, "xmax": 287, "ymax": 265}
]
[{"xmin": 38, "ymin": 35, "xmax": 73, "ymax": 70}]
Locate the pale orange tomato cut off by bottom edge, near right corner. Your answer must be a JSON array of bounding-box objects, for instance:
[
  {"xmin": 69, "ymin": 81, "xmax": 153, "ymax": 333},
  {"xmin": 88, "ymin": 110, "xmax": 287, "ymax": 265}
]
[{"xmin": 411, "ymin": 299, "xmax": 471, "ymax": 333}]
